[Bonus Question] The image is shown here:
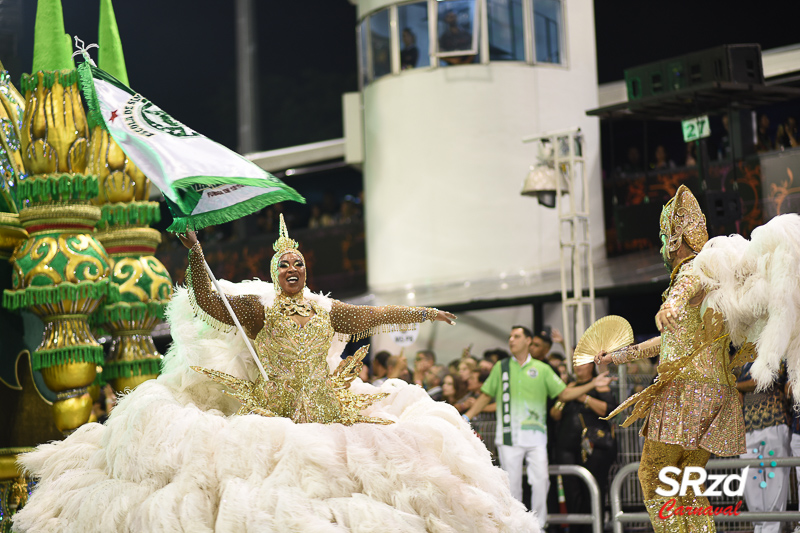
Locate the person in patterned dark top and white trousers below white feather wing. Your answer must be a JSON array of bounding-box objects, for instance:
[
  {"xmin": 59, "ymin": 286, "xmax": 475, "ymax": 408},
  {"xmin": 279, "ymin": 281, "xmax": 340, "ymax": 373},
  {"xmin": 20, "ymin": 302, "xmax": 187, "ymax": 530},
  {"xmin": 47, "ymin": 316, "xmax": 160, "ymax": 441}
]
[{"xmin": 736, "ymin": 363, "xmax": 791, "ymax": 533}]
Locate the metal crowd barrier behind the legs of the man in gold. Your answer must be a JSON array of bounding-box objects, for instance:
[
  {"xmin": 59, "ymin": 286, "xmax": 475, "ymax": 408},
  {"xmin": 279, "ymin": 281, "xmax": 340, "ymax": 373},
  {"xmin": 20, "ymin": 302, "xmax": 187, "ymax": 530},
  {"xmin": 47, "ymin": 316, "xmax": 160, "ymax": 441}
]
[{"xmin": 608, "ymin": 457, "xmax": 800, "ymax": 533}]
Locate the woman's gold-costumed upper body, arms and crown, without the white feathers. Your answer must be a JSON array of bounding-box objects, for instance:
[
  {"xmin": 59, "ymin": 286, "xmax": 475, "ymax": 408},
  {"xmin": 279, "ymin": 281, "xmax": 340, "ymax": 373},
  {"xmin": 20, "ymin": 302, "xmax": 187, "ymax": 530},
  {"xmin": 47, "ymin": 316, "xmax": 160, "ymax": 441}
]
[{"xmin": 178, "ymin": 215, "xmax": 456, "ymax": 425}]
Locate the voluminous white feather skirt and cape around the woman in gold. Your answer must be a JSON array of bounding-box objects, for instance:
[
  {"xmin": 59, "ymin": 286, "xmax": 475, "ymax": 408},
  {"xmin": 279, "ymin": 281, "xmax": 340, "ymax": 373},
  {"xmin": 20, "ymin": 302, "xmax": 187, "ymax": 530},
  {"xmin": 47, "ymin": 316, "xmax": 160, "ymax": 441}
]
[{"xmin": 13, "ymin": 283, "xmax": 540, "ymax": 533}]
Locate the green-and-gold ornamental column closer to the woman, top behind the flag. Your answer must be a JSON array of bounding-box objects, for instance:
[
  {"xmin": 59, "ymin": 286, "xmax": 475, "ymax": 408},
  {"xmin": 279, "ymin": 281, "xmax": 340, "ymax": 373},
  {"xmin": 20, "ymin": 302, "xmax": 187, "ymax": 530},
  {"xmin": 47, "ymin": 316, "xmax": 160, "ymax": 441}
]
[{"xmin": 89, "ymin": 123, "xmax": 172, "ymax": 391}]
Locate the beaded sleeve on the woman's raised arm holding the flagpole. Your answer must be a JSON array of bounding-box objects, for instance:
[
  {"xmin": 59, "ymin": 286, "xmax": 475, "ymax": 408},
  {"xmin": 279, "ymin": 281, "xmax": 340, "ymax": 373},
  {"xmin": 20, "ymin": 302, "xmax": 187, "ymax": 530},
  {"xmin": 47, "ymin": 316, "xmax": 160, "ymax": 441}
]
[{"xmin": 186, "ymin": 242, "xmax": 264, "ymax": 338}]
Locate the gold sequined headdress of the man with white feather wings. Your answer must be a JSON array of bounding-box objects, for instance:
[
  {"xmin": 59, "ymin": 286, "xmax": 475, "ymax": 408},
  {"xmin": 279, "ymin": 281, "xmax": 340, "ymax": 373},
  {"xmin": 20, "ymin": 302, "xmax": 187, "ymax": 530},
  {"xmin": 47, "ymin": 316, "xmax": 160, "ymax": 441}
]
[{"xmin": 661, "ymin": 185, "xmax": 708, "ymax": 252}]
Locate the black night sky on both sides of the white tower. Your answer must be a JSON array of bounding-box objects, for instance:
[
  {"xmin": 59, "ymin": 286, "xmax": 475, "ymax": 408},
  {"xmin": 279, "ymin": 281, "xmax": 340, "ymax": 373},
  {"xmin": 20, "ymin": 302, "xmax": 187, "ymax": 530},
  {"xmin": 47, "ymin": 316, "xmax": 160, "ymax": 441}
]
[{"xmin": 9, "ymin": 0, "xmax": 800, "ymax": 154}]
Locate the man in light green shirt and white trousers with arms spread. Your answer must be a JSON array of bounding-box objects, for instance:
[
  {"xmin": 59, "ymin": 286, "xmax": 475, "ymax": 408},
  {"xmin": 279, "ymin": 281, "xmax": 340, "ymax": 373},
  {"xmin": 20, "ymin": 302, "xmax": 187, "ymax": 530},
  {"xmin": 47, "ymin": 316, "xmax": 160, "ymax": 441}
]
[{"xmin": 464, "ymin": 326, "xmax": 611, "ymax": 526}]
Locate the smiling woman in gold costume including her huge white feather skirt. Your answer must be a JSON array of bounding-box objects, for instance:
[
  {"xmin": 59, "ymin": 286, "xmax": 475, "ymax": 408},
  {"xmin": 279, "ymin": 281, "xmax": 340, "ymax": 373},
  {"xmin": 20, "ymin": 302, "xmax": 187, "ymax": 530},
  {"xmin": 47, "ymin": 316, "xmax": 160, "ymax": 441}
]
[{"xmin": 13, "ymin": 214, "xmax": 541, "ymax": 533}]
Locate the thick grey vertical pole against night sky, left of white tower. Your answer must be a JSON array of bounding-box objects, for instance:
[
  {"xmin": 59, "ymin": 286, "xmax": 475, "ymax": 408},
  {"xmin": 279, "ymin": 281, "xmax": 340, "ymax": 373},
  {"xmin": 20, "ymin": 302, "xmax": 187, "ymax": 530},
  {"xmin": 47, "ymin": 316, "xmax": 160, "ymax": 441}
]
[{"xmin": 236, "ymin": 0, "xmax": 258, "ymax": 154}]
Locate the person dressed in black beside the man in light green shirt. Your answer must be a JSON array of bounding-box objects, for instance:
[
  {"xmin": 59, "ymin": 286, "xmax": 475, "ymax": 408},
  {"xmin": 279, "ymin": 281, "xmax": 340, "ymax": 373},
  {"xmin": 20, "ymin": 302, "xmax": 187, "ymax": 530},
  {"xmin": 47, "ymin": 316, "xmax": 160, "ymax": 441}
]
[{"xmin": 550, "ymin": 364, "xmax": 618, "ymax": 533}]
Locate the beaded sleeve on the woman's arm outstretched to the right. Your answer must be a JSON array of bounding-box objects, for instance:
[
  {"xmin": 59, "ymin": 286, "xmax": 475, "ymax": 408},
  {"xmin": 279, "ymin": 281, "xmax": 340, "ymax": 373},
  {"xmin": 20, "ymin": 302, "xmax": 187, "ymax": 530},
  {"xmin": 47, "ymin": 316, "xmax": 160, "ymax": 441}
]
[{"xmin": 331, "ymin": 300, "xmax": 439, "ymax": 340}]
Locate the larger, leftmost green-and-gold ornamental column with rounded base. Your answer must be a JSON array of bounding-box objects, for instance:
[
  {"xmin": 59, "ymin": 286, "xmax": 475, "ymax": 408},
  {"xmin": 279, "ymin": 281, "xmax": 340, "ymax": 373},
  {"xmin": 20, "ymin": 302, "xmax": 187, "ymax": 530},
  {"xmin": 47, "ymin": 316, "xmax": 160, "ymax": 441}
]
[{"xmin": 3, "ymin": 70, "xmax": 117, "ymax": 434}]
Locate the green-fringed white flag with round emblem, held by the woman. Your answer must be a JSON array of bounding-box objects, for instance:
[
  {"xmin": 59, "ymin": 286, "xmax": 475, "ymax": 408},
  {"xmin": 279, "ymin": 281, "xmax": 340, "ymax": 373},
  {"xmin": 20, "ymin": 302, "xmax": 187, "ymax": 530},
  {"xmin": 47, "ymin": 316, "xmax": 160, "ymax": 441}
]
[{"xmin": 78, "ymin": 61, "xmax": 305, "ymax": 231}]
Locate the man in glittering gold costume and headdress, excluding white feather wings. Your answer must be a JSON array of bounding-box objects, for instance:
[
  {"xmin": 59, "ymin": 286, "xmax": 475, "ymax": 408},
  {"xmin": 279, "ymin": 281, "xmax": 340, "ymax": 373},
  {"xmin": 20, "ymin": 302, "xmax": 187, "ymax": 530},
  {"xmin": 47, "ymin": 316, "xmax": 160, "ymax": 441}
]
[{"xmin": 596, "ymin": 185, "xmax": 745, "ymax": 533}]
